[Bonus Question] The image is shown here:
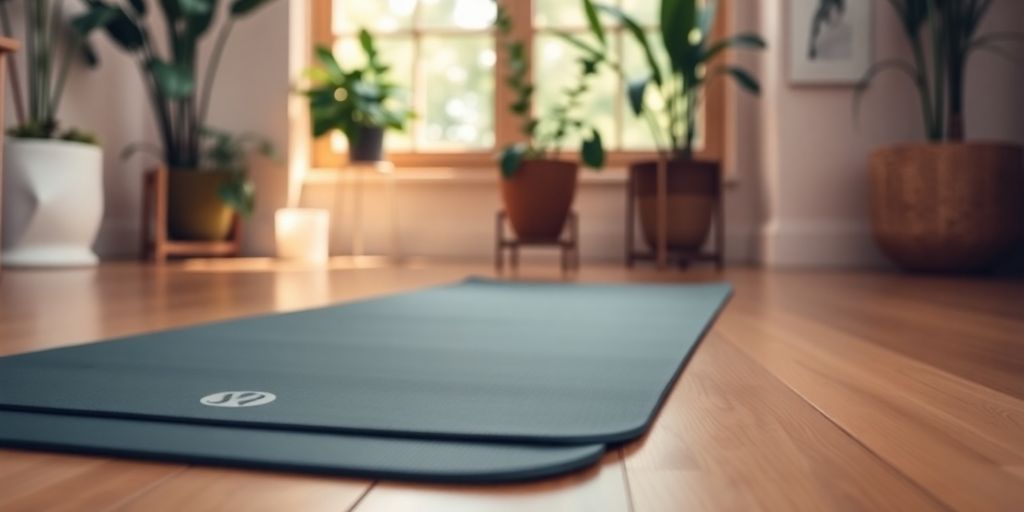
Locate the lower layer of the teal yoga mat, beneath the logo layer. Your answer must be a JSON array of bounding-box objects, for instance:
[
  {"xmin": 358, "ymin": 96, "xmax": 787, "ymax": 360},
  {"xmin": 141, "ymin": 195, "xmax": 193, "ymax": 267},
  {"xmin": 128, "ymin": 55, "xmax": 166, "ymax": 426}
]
[{"xmin": 0, "ymin": 411, "xmax": 604, "ymax": 483}]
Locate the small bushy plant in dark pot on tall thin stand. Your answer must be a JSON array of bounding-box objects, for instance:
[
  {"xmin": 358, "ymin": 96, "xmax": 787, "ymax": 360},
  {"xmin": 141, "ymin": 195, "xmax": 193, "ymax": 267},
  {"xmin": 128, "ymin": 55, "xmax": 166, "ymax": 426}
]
[{"xmin": 303, "ymin": 29, "xmax": 413, "ymax": 162}]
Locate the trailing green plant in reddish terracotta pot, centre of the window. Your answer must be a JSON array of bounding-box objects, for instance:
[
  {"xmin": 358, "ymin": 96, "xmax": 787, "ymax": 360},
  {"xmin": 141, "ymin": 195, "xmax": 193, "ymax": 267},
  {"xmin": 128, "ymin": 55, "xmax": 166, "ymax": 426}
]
[{"xmin": 496, "ymin": 0, "xmax": 605, "ymax": 241}]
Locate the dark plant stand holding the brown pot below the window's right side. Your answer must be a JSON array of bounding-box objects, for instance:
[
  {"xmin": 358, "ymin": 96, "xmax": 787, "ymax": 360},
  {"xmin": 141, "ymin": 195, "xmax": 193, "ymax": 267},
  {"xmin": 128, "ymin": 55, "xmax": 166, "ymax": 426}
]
[{"xmin": 626, "ymin": 160, "xmax": 725, "ymax": 271}]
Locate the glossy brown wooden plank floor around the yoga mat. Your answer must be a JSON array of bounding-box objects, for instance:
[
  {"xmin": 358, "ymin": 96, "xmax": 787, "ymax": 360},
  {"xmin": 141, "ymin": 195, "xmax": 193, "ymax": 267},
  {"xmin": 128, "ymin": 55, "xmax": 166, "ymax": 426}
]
[{"xmin": 0, "ymin": 261, "xmax": 1024, "ymax": 512}]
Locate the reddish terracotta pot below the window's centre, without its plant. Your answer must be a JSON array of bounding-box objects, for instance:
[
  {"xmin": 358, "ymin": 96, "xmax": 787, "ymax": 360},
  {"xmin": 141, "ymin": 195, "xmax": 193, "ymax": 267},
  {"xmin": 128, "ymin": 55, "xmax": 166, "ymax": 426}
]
[{"xmin": 502, "ymin": 160, "xmax": 580, "ymax": 241}]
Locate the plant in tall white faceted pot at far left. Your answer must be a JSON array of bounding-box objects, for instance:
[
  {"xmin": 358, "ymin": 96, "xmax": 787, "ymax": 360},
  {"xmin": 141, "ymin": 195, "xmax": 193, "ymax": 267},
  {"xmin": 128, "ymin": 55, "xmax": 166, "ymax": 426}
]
[{"xmin": 0, "ymin": 0, "xmax": 103, "ymax": 266}]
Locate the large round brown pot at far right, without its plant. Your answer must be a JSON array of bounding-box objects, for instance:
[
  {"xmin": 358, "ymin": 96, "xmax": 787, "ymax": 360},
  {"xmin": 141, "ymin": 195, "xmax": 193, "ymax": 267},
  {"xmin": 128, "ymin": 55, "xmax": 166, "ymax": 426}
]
[{"xmin": 870, "ymin": 143, "xmax": 1024, "ymax": 272}]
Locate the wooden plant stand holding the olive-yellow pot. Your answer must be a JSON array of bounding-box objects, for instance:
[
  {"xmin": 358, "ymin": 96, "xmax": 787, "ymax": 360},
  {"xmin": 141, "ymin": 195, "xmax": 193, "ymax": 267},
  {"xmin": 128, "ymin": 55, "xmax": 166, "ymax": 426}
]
[{"xmin": 141, "ymin": 168, "xmax": 242, "ymax": 263}]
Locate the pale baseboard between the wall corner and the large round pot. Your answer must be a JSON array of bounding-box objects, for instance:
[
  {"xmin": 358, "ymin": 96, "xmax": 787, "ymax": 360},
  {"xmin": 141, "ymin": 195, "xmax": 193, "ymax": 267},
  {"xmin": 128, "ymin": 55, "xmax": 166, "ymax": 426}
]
[{"xmin": 759, "ymin": 220, "xmax": 890, "ymax": 268}]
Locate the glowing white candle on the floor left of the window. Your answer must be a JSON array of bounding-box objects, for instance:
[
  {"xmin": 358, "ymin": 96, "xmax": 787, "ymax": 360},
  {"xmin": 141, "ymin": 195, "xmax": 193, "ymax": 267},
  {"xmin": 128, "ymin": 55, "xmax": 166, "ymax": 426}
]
[{"xmin": 274, "ymin": 208, "xmax": 331, "ymax": 264}]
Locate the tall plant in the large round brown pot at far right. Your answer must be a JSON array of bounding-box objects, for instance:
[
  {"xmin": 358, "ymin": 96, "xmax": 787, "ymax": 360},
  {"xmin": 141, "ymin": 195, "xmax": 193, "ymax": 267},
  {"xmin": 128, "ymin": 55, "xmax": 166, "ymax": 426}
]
[{"xmin": 856, "ymin": 0, "xmax": 1024, "ymax": 271}]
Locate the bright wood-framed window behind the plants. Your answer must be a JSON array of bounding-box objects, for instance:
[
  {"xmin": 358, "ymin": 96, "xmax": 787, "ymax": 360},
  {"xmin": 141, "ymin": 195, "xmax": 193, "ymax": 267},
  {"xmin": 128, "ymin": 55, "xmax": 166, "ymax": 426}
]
[{"xmin": 313, "ymin": 0, "xmax": 726, "ymax": 167}]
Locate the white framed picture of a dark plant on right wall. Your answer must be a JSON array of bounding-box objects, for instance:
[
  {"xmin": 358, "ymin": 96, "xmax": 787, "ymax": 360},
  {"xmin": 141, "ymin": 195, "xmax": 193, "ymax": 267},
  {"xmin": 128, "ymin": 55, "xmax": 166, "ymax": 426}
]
[{"xmin": 790, "ymin": 0, "xmax": 873, "ymax": 85}]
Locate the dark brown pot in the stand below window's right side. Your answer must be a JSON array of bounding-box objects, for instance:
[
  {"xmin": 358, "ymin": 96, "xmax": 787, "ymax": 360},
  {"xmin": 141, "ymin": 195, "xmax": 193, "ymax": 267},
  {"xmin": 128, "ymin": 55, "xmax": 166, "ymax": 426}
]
[{"xmin": 630, "ymin": 160, "xmax": 720, "ymax": 251}]
